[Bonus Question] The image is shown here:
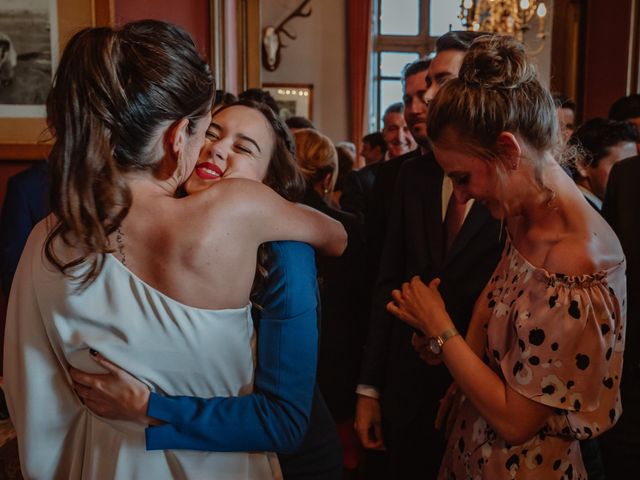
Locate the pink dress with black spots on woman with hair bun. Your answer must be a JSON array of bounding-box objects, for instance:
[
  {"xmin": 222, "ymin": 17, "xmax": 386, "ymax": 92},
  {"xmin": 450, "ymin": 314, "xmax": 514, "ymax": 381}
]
[{"xmin": 439, "ymin": 238, "xmax": 625, "ymax": 480}]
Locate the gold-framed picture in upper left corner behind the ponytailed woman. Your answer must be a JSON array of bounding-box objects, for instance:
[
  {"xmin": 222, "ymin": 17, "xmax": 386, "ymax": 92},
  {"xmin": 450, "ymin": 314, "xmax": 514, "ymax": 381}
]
[{"xmin": 0, "ymin": 0, "xmax": 113, "ymax": 160}]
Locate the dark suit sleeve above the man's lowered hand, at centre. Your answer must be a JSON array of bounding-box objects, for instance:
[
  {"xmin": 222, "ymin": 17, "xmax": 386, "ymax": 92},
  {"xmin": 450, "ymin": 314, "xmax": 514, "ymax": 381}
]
[{"xmin": 359, "ymin": 169, "xmax": 405, "ymax": 388}]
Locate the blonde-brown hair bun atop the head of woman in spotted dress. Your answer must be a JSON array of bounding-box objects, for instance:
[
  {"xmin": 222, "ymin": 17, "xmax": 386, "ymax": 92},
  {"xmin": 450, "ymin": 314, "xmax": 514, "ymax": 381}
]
[{"xmin": 459, "ymin": 35, "xmax": 536, "ymax": 89}]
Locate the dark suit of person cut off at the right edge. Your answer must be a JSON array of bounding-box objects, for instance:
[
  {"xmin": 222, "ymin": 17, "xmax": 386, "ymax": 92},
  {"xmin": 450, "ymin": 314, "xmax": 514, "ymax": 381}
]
[{"xmin": 600, "ymin": 156, "xmax": 640, "ymax": 479}]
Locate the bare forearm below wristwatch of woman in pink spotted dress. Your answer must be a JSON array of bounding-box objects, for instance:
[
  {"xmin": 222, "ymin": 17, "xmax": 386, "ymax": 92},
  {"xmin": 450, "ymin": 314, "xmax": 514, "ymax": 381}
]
[{"xmin": 442, "ymin": 335, "xmax": 551, "ymax": 445}]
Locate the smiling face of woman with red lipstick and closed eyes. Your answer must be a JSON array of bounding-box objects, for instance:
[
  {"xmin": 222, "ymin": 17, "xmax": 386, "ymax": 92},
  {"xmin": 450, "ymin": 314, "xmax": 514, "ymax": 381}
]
[{"xmin": 185, "ymin": 105, "xmax": 275, "ymax": 195}]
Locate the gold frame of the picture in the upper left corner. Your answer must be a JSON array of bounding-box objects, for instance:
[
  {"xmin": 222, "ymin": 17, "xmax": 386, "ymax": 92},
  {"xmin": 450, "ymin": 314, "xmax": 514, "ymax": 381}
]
[{"xmin": 0, "ymin": 0, "xmax": 114, "ymax": 160}]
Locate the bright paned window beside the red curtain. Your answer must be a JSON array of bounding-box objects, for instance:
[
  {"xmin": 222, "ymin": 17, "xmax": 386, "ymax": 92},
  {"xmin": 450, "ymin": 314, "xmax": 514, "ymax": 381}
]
[{"xmin": 369, "ymin": 0, "xmax": 462, "ymax": 132}]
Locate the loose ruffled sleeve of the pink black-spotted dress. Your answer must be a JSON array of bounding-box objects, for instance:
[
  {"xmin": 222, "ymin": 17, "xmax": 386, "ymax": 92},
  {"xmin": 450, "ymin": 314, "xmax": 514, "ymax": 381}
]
[{"xmin": 494, "ymin": 263, "xmax": 625, "ymax": 412}]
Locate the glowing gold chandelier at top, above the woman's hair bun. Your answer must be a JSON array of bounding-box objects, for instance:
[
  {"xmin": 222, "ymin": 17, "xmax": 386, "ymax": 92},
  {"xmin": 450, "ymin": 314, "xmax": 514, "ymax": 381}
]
[{"xmin": 458, "ymin": 0, "xmax": 547, "ymax": 42}]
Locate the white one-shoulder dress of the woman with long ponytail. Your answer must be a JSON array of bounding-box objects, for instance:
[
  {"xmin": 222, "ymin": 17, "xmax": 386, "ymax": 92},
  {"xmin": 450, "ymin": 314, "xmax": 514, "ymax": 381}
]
[{"xmin": 4, "ymin": 219, "xmax": 280, "ymax": 480}]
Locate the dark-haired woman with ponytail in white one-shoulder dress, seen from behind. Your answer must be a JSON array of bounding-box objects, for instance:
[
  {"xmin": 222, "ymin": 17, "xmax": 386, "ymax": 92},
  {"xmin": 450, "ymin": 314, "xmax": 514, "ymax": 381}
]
[{"xmin": 4, "ymin": 21, "xmax": 346, "ymax": 479}]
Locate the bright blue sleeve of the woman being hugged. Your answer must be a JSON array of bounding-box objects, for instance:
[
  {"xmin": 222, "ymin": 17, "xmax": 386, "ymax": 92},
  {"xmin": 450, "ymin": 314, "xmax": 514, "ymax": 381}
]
[{"xmin": 146, "ymin": 242, "xmax": 318, "ymax": 453}]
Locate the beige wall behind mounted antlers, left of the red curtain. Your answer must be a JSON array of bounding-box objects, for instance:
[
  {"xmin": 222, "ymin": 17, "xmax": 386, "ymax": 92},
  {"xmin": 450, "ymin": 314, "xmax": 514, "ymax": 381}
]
[{"xmin": 261, "ymin": 0, "xmax": 349, "ymax": 142}]
